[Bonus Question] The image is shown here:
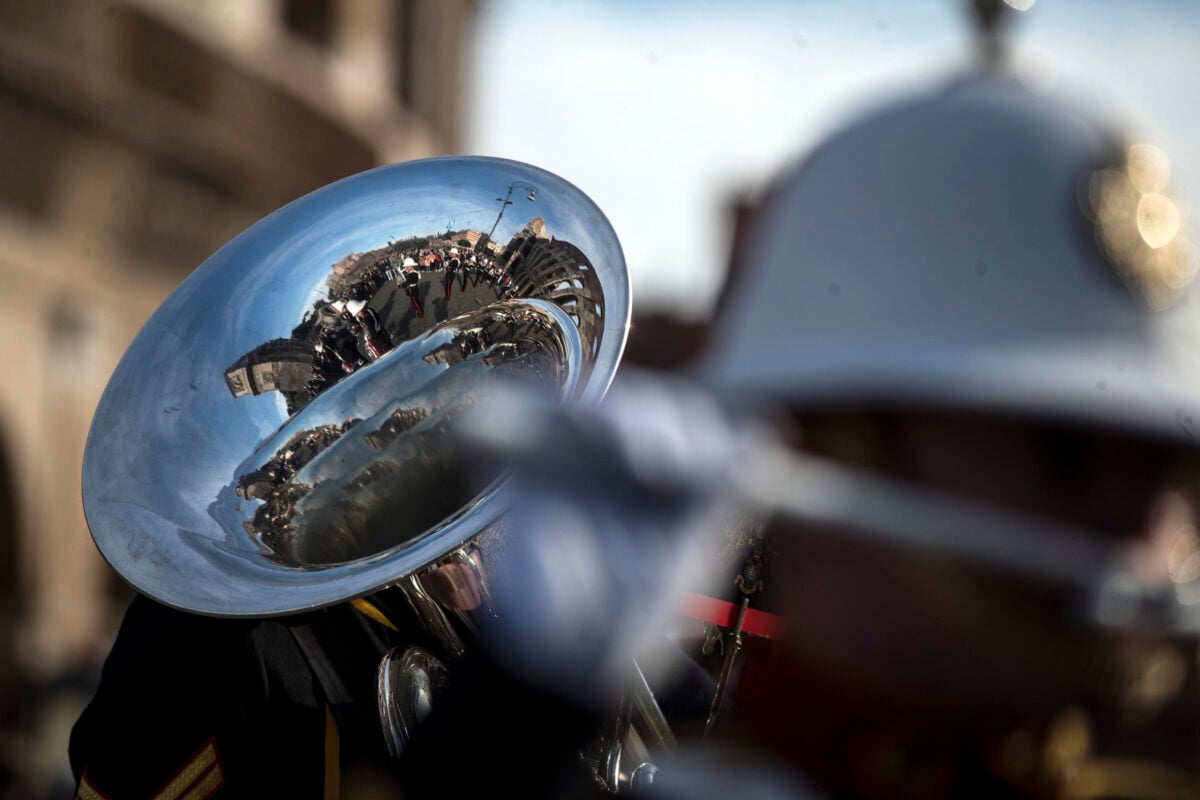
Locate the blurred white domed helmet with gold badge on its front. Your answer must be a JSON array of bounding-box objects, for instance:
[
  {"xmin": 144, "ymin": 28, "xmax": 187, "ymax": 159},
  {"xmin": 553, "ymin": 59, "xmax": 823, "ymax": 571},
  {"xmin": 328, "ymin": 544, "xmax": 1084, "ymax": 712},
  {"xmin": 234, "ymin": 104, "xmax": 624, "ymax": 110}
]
[{"xmin": 701, "ymin": 74, "xmax": 1200, "ymax": 440}]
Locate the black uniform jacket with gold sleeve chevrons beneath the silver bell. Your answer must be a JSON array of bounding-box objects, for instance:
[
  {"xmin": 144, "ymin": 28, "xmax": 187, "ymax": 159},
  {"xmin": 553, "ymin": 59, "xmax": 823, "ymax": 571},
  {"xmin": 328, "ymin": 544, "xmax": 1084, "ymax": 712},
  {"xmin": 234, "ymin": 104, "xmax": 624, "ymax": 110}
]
[{"xmin": 70, "ymin": 596, "xmax": 427, "ymax": 800}]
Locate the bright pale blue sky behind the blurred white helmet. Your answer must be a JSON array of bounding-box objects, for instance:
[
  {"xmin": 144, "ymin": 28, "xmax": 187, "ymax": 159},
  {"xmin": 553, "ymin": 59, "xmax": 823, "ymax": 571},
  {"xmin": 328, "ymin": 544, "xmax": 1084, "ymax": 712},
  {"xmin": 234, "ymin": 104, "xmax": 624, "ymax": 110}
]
[{"xmin": 466, "ymin": 0, "xmax": 1200, "ymax": 315}]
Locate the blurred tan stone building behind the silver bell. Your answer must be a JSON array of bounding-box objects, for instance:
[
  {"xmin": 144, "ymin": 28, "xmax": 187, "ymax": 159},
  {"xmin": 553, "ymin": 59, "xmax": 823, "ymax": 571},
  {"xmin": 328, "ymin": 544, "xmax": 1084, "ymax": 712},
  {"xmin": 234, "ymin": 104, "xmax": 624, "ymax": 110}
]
[{"xmin": 0, "ymin": 0, "xmax": 476, "ymax": 796}]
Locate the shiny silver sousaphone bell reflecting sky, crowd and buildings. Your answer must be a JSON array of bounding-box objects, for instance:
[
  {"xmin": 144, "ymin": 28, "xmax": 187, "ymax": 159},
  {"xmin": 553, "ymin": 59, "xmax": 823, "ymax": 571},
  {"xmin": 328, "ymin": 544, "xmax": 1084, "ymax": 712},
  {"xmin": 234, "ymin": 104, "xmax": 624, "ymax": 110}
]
[{"xmin": 83, "ymin": 157, "xmax": 629, "ymax": 616}]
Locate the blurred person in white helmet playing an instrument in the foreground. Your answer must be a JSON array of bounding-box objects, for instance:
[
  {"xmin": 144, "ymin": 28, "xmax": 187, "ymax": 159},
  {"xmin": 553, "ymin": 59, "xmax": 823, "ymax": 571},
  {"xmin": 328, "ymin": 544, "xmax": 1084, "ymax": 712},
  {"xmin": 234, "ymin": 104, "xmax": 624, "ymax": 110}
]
[{"xmin": 681, "ymin": 28, "xmax": 1200, "ymax": 799}]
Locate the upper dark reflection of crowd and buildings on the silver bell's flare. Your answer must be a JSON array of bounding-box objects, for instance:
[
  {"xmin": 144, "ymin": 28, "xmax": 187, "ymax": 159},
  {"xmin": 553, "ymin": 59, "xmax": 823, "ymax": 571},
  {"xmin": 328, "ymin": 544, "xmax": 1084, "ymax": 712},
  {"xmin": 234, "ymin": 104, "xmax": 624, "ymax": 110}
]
[{"xmin": 226, "ymin": 217, "xmax": 604, "ymax": 416}]
